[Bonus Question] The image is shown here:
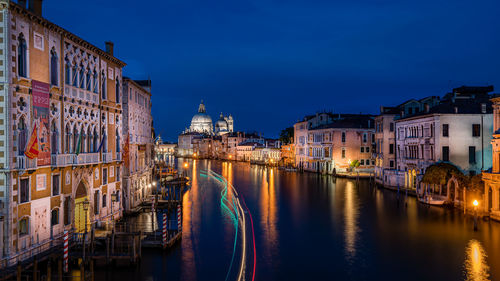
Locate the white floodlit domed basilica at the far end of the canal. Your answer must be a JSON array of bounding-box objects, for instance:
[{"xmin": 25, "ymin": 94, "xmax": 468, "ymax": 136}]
[{"xmin": 184, "ymin": 101, "xmax": 234, "ymax": 136}]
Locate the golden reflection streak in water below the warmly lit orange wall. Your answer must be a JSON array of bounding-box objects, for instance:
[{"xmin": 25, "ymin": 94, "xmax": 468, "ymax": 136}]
[{"xmin": 344, "ymin": 181, "xmax": 359, "ymax": 260}]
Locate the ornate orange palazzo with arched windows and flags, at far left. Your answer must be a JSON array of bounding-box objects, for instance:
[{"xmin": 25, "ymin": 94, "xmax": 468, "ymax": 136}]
[{"xmin": 0, "ymin": 0, "xmax": 125, "ymax": 265}]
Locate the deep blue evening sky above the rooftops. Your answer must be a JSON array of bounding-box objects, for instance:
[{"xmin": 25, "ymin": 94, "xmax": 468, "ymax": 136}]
[{"xmin": 43, "ymin": 0, "xmax": 500, "ymax": 141}]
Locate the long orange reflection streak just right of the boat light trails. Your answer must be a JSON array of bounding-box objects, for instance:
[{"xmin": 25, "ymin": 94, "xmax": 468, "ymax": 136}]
[{"xmin": 259, "ymin": 168, "xmax": 278, "ymax": 257}]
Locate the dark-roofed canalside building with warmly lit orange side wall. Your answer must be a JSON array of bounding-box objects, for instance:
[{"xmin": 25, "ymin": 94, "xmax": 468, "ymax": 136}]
[{"xmin": 294, "ymin": 113, "xmax": 375, "ymax": 174}]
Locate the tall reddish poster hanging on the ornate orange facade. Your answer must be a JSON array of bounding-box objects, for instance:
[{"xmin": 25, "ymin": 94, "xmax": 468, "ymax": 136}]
[{"xmin": 31, "ymin": 80, "xmax": 50, "ymax": 166}]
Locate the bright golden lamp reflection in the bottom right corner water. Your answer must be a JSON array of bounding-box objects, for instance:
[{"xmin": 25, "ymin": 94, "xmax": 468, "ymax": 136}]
[{"xmin": 464, "ymin": 239, "xmax": 490, "ymax": 281}]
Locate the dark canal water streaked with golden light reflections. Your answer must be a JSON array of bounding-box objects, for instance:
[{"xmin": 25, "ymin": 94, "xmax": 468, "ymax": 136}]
[{"xmin": 96, "ymin": 159, "xmax": 500, "ymax": 280}]
